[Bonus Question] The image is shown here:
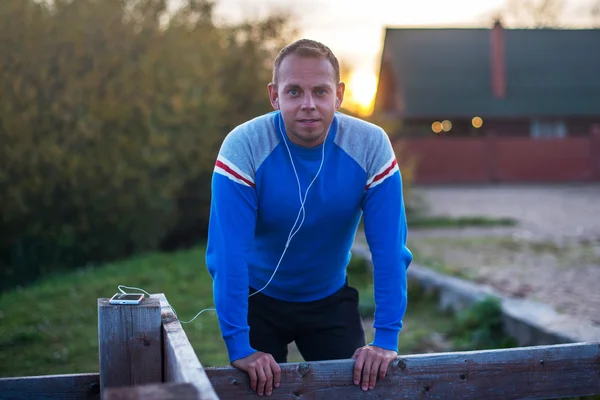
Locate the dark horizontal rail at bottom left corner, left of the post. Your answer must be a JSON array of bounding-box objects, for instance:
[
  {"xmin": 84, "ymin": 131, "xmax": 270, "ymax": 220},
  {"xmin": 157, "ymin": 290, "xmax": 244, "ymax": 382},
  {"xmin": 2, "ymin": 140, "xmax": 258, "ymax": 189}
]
[{"xmin": 0, "ymin": 373, "xmax": 100, "ymax": 400}]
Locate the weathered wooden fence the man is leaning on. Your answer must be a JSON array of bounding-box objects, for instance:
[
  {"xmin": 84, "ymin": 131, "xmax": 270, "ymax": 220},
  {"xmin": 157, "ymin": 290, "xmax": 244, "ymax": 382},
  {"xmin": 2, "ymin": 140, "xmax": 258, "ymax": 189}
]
[{"xmin": 0, "ymin": 294, "xmax": 600, "ymax": 400}]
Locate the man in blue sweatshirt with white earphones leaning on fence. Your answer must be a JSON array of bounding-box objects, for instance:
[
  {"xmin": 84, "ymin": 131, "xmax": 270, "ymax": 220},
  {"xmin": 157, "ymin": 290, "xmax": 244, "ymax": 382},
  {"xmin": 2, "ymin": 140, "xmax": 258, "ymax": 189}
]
[{"xmin": 206, "ymin": 39, "xmax": 412, "ymax": 395}]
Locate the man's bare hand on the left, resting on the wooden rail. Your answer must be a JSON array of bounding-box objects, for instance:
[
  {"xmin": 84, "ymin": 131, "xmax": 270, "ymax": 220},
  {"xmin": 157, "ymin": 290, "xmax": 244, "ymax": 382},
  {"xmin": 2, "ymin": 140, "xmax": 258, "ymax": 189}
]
[{"xmin": 231, "ymin": 351, "xmax": 281, "ymax": 396}]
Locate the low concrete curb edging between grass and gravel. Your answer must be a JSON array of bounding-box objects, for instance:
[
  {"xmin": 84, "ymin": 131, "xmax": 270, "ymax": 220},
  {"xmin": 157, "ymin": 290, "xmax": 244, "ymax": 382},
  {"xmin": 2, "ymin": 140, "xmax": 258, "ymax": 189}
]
[{"xmin": 352, "ymin": 244, "xmax": 600, "ymax": 346}]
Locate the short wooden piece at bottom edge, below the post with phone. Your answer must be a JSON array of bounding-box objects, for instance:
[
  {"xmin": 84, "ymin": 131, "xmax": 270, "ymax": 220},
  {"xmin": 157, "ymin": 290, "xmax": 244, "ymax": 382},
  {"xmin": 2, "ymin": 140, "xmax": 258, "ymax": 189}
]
[{"xmin": 102, "ymin": 383, "xmax": 200, "ymax": 400}]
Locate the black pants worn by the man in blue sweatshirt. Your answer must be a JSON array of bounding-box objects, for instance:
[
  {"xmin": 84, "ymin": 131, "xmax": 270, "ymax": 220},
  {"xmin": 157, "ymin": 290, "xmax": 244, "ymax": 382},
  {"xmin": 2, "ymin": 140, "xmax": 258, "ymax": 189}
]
[{"xmin": 248, "ymin": 285, "xmax": 366, "ymax": 363}]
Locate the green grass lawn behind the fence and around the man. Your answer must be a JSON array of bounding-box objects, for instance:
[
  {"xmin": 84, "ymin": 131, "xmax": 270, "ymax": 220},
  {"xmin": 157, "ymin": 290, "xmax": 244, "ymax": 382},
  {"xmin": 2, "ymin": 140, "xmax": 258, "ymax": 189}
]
[{"xmin": 0, "ymin": 247, "xmax": 450, "ymax": 377}]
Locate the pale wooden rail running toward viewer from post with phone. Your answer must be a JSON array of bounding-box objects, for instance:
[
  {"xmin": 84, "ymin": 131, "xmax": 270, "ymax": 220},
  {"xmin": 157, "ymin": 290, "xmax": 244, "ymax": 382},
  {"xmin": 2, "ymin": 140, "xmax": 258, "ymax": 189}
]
[{"xmin": 152, "ymin": 293, "xmax": 219, "ymax": 400}]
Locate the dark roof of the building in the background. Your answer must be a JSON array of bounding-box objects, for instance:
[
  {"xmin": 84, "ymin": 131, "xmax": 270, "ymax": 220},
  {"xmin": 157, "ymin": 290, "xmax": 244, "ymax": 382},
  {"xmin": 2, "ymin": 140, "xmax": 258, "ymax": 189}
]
[{"xmin": 376, "ymin": 28, "xmax": 600, "ymax": 117}]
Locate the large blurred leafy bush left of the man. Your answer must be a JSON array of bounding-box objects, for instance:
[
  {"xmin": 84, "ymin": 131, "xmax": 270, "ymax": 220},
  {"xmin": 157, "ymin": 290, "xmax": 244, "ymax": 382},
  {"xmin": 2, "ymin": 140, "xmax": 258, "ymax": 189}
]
[{"xmin": 0, "ymin": 0, "xmax": 293, "ymax": 289}]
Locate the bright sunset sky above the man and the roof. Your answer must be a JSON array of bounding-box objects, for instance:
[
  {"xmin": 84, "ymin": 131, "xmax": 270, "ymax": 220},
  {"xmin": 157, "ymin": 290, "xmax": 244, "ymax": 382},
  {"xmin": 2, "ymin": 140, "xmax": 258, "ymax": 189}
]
[{"xmin": 207, "ymin": 0, "xmax": 594, "ymax": 112}]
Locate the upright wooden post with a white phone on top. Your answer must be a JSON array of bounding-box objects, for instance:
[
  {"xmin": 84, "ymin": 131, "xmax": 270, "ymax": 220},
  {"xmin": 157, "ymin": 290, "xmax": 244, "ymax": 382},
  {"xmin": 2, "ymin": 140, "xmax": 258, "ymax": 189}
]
[{"xmin": 98, "ymin": 297, "xmax": 163, "ymax": 392}]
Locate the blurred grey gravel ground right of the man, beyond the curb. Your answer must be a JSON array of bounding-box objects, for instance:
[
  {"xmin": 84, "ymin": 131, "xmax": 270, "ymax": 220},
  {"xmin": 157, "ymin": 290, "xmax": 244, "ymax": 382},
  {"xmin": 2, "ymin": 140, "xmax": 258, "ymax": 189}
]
[{"xmin": 408, "ymin": 184, "xmax": 600, "ymax": 325}]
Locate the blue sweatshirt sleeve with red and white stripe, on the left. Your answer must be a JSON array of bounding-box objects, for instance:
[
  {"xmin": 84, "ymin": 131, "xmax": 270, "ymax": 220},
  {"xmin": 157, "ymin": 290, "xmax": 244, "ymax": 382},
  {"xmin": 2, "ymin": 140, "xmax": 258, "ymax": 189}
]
[{"xmin": 206, "ymin": 131, "xmax": 257, "ymax": 362}]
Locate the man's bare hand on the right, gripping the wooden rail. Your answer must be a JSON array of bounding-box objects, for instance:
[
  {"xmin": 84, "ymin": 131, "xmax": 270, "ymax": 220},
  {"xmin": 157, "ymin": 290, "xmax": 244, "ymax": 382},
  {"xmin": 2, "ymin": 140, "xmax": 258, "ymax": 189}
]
[{"xmin": 352, "ymin": 346, "xmax": 398, "ymax": 390}]
